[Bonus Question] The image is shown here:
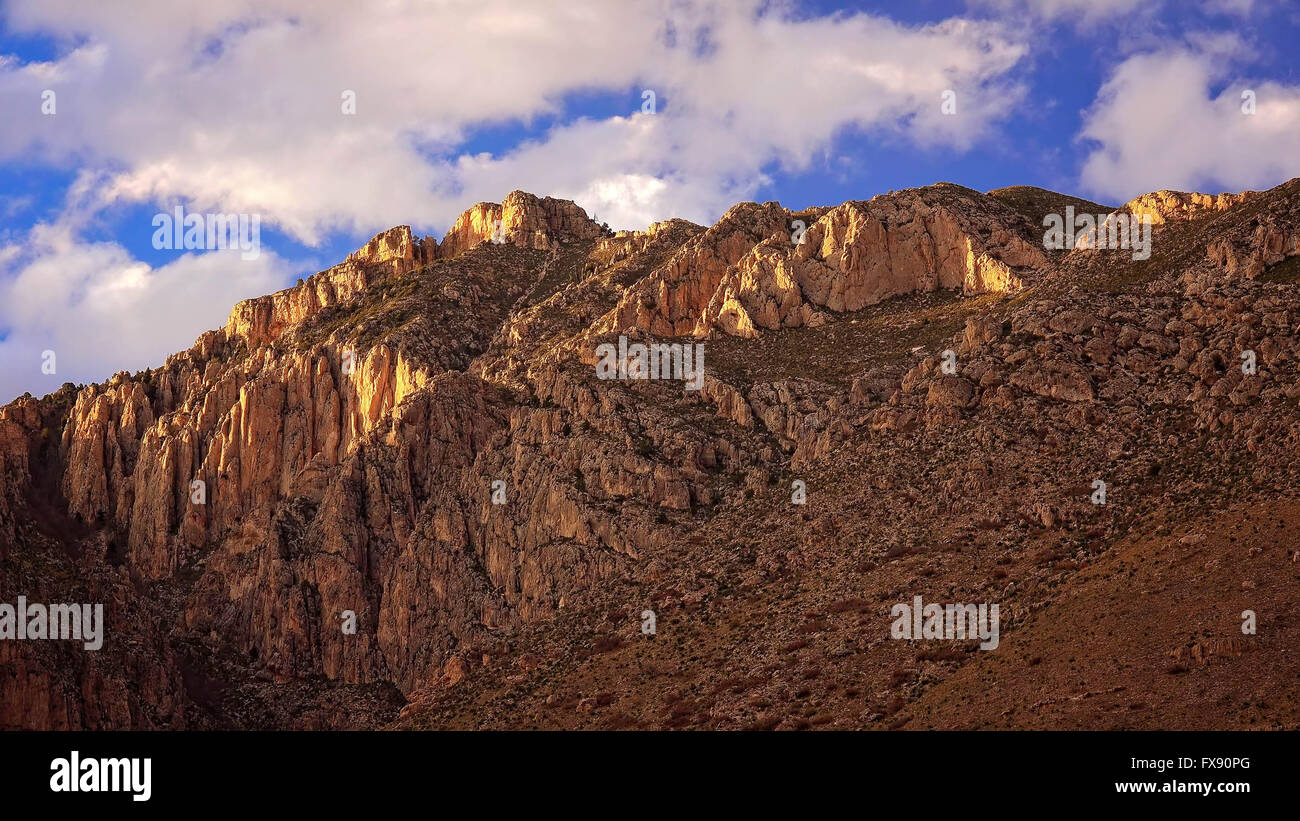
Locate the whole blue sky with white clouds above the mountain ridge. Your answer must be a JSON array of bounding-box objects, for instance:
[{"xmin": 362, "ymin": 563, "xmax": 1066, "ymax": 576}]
[{"xmin": 0, "ymin": 0, "xmax": 1300, "ymax": 403}]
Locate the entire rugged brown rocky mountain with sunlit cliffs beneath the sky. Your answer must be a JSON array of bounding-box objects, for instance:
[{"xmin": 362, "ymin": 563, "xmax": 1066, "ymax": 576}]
[{"xmin": 0, "ymin": 179, "xmax": 1300, "ymax": 729}]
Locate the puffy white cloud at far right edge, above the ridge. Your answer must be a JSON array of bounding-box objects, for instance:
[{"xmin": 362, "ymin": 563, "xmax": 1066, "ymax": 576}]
[{"xmin": 1080, "ymin": 45, "xmax": 1300, "ymax": 200}]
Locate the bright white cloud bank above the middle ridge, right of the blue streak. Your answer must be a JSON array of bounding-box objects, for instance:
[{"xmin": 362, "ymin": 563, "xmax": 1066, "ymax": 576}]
[{"xmin": 405, "ymin": 13, "xmax": 1024, "ymax": 227}]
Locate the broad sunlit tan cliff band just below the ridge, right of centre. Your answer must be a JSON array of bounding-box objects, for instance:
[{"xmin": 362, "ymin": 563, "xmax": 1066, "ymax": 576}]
[{"xmin": 605, "ymin": 184, "xmax": 1047, "ymax": 338}]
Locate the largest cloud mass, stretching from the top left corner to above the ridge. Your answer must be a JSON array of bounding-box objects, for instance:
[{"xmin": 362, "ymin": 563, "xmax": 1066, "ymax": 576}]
[{"xmin": 0, "ymin": 0, "xmax": 1024, "ymax": 237}]
